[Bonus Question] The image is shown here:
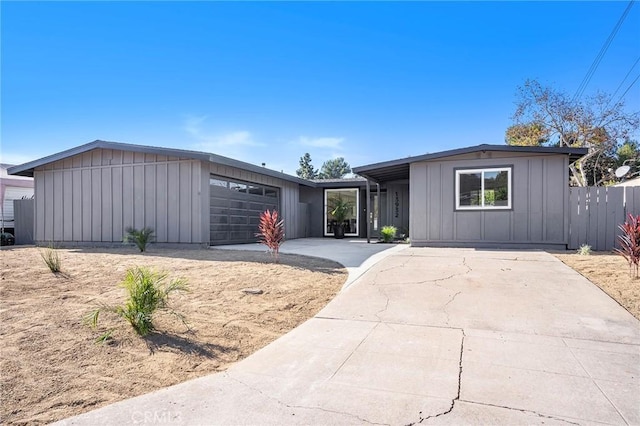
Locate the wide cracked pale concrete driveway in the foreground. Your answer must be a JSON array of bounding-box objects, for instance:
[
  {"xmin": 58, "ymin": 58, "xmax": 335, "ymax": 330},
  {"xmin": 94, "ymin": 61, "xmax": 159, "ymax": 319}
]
[{"xmin": 60, "ymin": 246, "xmax": 640, "ymax": 425}]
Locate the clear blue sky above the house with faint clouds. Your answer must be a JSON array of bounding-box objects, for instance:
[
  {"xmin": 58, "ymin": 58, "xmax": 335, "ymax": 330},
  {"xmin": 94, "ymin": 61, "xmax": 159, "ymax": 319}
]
[{"xmin": 0, "ymin": 1, "xmax": 640, "ymax": 174}]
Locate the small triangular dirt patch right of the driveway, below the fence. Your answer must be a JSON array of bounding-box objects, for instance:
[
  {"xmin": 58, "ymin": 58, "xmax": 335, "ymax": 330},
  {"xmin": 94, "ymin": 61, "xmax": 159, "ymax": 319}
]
[{"xmin": 552, "ymin": 252, "xmax": 640, "ymax": 320}]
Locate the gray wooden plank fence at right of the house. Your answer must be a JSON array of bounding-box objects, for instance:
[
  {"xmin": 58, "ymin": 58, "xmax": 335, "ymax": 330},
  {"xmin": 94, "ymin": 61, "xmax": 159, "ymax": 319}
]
[{"xmin": 567, "ymin": 186, "xmax": 640, "ymax": 251}]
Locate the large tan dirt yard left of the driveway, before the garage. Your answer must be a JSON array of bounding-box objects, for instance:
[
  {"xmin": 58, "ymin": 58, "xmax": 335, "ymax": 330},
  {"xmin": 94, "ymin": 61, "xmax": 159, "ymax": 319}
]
[{"xmin": 0, "ymin": 247, "xmax": 347, "ymax": 424}]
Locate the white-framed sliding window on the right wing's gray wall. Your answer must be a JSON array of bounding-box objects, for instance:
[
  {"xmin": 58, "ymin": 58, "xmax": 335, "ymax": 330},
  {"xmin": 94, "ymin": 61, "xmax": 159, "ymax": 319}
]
[{"xmin": 456, "ymin": 167, "xmax": 512, "ymax": 210}]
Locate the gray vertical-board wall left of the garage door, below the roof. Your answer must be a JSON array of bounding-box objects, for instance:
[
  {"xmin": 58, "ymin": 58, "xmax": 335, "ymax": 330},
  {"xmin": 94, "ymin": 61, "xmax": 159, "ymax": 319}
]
[{"xmin": 34, "ymin": 148, "xmax": 209, "ymax": 244}]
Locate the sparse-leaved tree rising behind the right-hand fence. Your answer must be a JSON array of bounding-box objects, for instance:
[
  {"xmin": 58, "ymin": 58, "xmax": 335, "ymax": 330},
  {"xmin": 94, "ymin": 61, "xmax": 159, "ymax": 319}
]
[{"xmin": 505, "ymin": 80, "xmax": 640, "ymax": 186}]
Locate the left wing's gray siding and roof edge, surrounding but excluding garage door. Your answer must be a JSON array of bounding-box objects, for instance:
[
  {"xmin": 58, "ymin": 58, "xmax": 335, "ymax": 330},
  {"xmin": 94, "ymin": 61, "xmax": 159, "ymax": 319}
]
[{"xmin": 10, "ymin": 141, "xmax": 308, "ymax": 245}]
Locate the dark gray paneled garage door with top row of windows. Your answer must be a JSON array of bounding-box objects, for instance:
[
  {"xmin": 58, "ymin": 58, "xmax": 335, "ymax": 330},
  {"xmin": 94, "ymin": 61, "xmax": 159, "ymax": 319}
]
[{"xmin": 209, "ymin": 175, "xmax": 280, "ymax": 245}]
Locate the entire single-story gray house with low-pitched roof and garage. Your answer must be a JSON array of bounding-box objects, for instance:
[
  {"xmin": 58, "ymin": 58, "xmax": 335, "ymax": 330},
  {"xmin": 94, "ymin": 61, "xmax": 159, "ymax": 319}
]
[{"xmin": 9, "ymin": 141, "xmax": 586, "ymax": 247}]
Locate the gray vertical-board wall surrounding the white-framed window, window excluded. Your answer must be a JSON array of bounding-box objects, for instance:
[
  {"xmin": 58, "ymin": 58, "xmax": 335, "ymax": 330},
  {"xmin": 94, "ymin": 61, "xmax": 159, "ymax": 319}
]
[{"xmin": 410, "ymin": 151, "xmax": 569, "ymax": 248}]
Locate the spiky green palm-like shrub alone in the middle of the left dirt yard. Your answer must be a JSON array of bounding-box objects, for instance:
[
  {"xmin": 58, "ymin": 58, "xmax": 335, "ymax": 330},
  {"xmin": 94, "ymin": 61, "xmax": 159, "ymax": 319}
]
[{"xmin": 85, "ymin": 267, "xmax": 188, "ymax": 340}]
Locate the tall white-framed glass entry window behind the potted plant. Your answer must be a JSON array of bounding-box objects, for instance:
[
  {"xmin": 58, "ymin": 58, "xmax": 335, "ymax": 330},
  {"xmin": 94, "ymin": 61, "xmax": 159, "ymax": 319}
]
[{"xmin": 324, "ymin": 188, "xmax": 360, "ymax": 237}]
